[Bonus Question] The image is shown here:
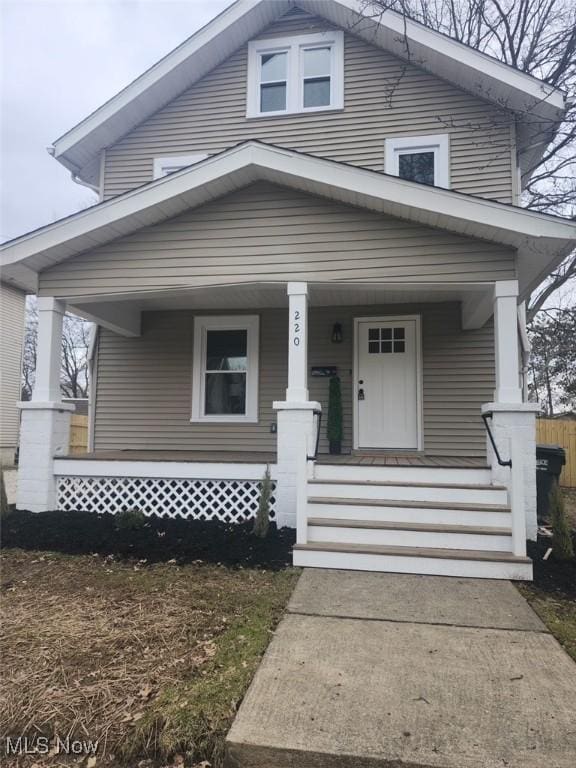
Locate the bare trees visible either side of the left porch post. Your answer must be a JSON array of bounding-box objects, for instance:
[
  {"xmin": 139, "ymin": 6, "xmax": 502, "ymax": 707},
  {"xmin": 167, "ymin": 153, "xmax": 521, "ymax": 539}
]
[{"xmin": 22, "ymin": 297, "xmax": 91, "ymax": 400}]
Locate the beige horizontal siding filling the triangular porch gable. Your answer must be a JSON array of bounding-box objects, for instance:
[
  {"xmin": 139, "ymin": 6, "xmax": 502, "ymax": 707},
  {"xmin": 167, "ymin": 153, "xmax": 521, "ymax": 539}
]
[{"xmin": 40, "ymin": 183, "xmax": 515, "ymax": 297}]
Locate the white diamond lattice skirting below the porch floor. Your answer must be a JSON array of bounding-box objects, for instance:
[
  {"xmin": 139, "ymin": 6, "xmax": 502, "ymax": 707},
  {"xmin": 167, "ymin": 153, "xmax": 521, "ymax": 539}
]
[{"xmin": 57, "ymin": 476, "xmax": 276, "ymax": 523}]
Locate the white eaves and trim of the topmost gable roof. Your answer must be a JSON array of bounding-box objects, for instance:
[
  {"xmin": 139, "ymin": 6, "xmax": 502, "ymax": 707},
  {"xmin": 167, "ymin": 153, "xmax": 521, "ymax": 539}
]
[{"xmin": 50, "ymin": 0, "xmax": 566, "ymax": 184}]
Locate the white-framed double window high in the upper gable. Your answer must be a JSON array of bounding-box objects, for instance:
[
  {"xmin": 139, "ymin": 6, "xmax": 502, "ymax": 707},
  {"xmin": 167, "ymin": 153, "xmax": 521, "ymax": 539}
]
[{"xmin": 247, "ymin": 31, "xmax": 344, "ymax": 117}]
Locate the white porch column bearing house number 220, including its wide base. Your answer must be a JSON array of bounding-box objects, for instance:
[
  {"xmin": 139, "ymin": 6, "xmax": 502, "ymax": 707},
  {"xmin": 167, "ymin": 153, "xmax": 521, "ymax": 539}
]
[{"xmin": 273, "ymin": 283, "xmax": 321, "ymax": 528}]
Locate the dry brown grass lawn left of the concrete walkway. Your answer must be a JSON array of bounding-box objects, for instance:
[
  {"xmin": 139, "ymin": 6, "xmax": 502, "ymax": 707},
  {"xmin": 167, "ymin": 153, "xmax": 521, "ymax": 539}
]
[{"xmin": 0, "ymin": 550, "xmax": 296, "ymax": 766}]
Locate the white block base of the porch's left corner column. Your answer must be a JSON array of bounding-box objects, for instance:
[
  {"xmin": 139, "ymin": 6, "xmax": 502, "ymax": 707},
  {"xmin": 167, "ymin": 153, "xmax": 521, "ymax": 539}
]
[{"xmin": 16, "ymin": 400, "xmax": 76, "ymax": 512}]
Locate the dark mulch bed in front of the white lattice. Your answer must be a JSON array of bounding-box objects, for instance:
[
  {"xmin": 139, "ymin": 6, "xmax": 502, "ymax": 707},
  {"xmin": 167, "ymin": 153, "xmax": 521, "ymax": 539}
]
[{"xmin": 1, "ymin": 511, "xmax": 295, "ymax": 570}]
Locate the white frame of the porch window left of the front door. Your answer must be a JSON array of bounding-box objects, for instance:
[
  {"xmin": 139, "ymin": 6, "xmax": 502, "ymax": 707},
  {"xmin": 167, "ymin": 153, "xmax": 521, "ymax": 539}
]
[{"xmin": 190, "ymin": 315, "xmax": 260, "ymax": 424}]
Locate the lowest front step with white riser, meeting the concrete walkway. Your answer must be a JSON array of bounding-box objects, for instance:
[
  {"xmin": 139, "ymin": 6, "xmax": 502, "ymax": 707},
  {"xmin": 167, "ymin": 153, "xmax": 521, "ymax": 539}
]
[{"xmin": 293, "ymin": 542, "xmax": 532, "ymax": 581}]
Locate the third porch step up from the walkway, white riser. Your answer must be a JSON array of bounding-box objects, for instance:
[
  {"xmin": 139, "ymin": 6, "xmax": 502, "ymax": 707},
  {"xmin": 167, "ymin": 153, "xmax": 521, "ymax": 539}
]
[{"xmin": 308, "ymin": 497, "xmax": 510, "ymax": 528}]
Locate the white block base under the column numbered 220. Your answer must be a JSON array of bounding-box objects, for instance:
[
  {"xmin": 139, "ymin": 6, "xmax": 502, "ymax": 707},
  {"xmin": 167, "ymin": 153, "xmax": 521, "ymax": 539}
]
[{"xmin": 273, "ymin": 401, "xmax": 321, "ymax": 528}]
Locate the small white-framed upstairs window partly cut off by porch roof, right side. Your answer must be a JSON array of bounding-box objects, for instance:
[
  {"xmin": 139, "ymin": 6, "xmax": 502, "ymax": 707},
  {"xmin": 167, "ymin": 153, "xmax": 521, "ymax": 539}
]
[{"xmin": 385, "ymin": 134, "xmax": 450, "ymax": 189}]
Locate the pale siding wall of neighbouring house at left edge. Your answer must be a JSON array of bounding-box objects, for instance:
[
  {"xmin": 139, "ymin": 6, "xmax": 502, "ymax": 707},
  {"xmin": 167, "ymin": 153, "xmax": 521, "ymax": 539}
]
[{"xmin": 0, "ymin": 283, "xmax": 26, "ymax": 464}]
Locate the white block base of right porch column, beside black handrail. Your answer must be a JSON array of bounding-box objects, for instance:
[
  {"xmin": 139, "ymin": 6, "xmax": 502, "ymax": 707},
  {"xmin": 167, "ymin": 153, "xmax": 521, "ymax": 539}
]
[{"xmin": 482, "ymin": 402, "xmax": 540, "ymax": 541}]
